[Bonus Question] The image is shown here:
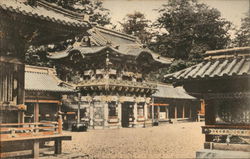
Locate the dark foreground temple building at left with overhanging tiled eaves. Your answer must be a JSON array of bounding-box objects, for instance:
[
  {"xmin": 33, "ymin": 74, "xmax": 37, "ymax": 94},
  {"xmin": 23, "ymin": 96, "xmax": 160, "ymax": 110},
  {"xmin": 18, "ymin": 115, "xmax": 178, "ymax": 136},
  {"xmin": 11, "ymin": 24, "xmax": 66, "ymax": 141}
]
[{"xmin": 0, "ymin": 0, "xmax": 91, "ymax": 123}]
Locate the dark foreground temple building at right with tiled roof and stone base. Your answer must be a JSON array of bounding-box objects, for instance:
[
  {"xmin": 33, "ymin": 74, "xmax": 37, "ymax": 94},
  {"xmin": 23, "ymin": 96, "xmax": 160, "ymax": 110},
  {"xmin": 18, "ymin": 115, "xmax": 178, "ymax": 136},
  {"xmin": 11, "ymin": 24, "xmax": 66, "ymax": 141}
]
[{"xmin": 165, "ymin": 47, "xmax": 250, "ymax": 158}]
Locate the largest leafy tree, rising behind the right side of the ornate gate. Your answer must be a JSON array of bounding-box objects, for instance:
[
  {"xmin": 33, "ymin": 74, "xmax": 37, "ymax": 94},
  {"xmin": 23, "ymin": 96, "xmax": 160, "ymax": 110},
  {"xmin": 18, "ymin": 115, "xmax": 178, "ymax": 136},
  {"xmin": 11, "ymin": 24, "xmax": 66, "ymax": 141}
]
[{"xmin": 150, "ymin": 0, "xmax": 231, "ymax": 67}]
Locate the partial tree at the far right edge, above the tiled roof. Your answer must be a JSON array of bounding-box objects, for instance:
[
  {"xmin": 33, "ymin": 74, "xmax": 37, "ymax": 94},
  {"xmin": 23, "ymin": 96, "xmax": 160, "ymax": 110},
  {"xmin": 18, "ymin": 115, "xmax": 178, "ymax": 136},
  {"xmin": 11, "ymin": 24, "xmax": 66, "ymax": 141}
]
[{"xmin": 233, "ymin": 13, "xmax": 250, "ymax": 47}]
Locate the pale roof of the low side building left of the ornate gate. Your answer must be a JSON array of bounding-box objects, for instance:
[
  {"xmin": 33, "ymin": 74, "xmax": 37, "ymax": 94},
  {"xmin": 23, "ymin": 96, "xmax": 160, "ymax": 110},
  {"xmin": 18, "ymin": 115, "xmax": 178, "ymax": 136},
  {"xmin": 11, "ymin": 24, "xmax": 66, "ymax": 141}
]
[{"xmin": 25, "ymin": 65, "xmax": 73, "ymax": 92}]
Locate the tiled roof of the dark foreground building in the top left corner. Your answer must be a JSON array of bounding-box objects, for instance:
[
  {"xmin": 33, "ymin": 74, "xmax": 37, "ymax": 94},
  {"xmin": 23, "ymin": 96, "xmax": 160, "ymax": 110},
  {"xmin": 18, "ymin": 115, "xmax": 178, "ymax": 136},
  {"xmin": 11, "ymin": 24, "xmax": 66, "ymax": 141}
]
[{"xmin": 0, "ymin": 0, "xmax": 89, "ymax": 28}]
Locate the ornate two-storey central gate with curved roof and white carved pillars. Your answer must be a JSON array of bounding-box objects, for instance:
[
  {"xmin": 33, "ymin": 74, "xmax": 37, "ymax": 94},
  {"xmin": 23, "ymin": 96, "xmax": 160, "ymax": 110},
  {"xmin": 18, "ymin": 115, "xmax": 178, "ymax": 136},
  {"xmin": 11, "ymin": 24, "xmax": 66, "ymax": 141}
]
[{"xmin": 48, "ymin": 26, "xmax": 171, "ymax": 129}]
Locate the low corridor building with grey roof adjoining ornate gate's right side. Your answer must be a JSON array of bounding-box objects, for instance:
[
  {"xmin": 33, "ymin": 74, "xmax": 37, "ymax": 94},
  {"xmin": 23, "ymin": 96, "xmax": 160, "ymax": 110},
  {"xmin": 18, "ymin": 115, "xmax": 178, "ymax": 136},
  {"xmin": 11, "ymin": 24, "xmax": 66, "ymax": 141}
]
[{"xmin": 152, "ymin": 83, "xmax": 201, "ymax": 124}]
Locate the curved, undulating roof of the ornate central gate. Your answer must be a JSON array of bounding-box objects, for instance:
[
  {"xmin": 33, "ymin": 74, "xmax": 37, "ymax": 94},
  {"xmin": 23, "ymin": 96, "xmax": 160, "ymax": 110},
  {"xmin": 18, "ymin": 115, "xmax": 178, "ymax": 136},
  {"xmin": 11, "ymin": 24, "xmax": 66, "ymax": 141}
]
[{"xmin": 48, "ymin": 26, "xmax": 172, "ymax": 64}]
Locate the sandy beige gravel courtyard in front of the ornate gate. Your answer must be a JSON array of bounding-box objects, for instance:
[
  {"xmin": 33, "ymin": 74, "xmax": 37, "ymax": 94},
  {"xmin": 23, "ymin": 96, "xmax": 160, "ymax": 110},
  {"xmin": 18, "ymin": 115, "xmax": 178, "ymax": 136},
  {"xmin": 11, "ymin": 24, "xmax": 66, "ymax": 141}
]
[{"xmin": 55, "ymin": 122, "xmax": 204, "ymax": 159}]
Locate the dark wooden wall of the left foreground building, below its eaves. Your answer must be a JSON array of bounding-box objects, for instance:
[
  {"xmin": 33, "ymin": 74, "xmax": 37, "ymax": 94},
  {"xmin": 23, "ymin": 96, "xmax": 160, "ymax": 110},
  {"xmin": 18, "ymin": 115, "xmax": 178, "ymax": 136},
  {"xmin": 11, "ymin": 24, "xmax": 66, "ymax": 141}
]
[{"xmin": 0, "ymin": 59, "xmax": 24, "ymax": 123}]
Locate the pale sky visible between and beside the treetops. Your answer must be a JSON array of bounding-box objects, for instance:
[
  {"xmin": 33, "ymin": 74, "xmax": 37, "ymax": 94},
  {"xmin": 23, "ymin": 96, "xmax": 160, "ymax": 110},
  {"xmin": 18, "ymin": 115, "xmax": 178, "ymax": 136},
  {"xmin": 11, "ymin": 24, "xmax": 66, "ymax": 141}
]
[{"xmin": 103, "ymin": 0, "xmax": 250, "ymax": 28}]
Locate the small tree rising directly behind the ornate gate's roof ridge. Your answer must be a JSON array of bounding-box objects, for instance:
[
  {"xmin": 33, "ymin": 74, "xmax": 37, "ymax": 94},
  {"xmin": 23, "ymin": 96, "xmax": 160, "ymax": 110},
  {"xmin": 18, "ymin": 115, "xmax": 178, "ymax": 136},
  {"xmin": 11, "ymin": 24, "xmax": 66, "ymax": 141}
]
[{"xmin": 120, "ymin": 11, "xmax": 152, "ymax": 43}]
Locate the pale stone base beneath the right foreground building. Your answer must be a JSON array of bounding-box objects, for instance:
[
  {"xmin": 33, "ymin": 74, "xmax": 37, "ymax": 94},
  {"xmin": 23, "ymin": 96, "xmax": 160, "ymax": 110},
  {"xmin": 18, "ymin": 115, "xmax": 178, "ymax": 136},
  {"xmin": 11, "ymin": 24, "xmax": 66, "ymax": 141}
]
[{"xmin": 196, "ymin": 149, "xmax": 250, "ymax": 158}]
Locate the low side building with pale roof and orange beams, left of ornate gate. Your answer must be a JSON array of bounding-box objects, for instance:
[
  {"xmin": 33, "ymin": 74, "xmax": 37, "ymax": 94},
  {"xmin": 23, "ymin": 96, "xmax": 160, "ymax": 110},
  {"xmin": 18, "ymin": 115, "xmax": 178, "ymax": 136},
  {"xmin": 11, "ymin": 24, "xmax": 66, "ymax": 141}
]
[{"xmin": 24, "ymin": 65, "xmax": 74, "ymax": 122}]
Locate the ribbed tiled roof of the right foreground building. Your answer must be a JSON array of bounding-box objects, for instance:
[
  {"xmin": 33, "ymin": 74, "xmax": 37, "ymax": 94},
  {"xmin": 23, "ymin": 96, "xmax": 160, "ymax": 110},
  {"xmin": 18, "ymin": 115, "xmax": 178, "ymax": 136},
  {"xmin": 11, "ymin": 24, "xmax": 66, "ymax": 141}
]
[{"xmin": 164, "ymin": 48, "xmax": 250, "ymax": 82}]
